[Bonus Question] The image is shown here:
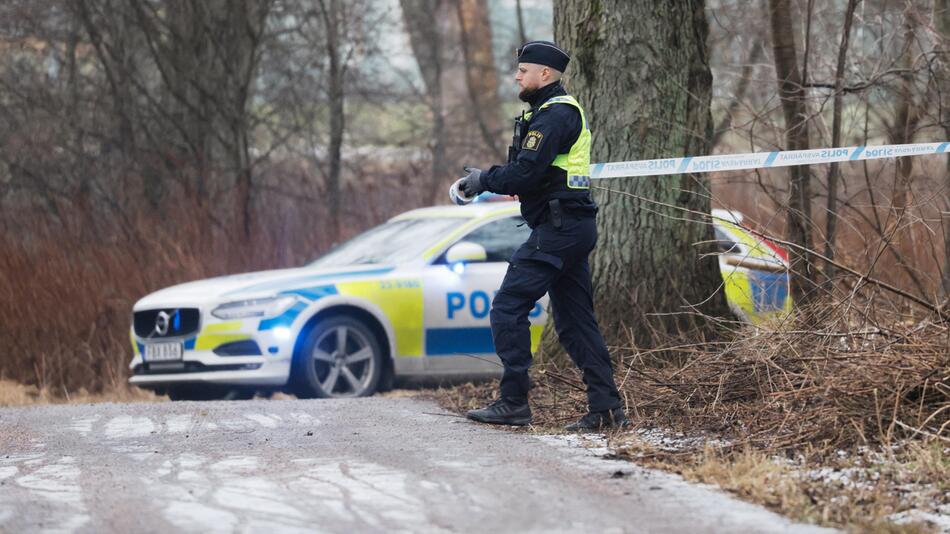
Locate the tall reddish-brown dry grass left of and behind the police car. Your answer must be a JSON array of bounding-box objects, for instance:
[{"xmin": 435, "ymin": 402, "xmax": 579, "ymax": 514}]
[{"xmin": 0, "ymin": 169, "xmax": 436, "ymax": 402}]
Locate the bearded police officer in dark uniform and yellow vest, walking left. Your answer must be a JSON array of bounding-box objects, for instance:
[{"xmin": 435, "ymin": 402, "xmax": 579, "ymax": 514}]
[{"xmin": 459, "ymin": 41, "xmax": 629, "ymax": 431}]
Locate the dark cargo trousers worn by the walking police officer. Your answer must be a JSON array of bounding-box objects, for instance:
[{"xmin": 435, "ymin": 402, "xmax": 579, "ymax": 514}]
[{"xmin": 491, "ymin": 214, "xmax": 620, "ymax": 411}]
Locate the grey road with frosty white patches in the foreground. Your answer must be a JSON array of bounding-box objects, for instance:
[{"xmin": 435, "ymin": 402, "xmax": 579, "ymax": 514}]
[{"xmin": 0, "ymin": 398, "xmax": 823, "ymax": 533}]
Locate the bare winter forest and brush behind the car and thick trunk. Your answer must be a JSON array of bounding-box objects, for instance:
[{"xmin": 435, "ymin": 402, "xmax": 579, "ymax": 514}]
[{"xmin": 0, "ymin": 0, "xmax": 950, "ymax": 410}]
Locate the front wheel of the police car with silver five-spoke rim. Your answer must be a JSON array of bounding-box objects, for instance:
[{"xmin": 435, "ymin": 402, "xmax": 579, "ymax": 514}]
[{"xmin": 294, "ymin": 316, "xmax": 383, "ymax": 398}]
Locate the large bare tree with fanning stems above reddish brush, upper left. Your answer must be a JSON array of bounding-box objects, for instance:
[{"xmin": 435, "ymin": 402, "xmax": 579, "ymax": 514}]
[{"xmin": 75, "ymin": 0, "xmax": 272, "ymax": 237}]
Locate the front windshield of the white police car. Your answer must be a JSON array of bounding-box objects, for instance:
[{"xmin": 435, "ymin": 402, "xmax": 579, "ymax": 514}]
[{"xmin": 310, "ymin": 217, "xmax": 468, "ymax": 267}]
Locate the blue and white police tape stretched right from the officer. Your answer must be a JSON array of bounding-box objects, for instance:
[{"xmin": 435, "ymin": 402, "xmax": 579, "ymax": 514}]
[{"xmin": 590, "ymin": 142, "xmax": 950, "ymax": 179}]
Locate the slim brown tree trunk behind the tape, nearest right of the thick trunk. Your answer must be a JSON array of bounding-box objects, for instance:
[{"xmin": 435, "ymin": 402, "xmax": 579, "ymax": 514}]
[{"xmin": 769, "ymin": 0, "xmax": 816, "ymax": 304}]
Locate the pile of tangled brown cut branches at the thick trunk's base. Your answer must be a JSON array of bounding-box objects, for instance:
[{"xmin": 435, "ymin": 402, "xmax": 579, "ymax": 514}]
[{"xmin": 532, "ymin": 308, "xmax": 950, "ymax": 450}]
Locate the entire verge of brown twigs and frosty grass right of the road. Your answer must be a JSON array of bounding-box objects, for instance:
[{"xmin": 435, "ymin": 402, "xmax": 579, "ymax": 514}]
[{"xmin": 438, "ymin": 299, "xmax": 950, "ymax": 532}]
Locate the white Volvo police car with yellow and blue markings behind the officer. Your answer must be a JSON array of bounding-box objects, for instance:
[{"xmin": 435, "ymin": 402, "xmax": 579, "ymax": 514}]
[{"xmin": 130, "ymin": 202, "xmax": 787, "ymax": 400}]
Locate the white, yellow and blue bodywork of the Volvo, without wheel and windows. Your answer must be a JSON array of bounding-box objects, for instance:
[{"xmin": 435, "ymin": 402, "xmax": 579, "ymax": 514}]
[{"xmin": 130, "ymin": 202, "xmax": 547, "ymax": 389}]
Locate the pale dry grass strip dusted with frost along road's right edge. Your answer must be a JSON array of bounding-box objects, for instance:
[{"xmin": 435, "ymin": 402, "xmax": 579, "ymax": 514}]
[{"xmin": 435, "ymin": 383, "xmax": 950, "ymax": 534}]
